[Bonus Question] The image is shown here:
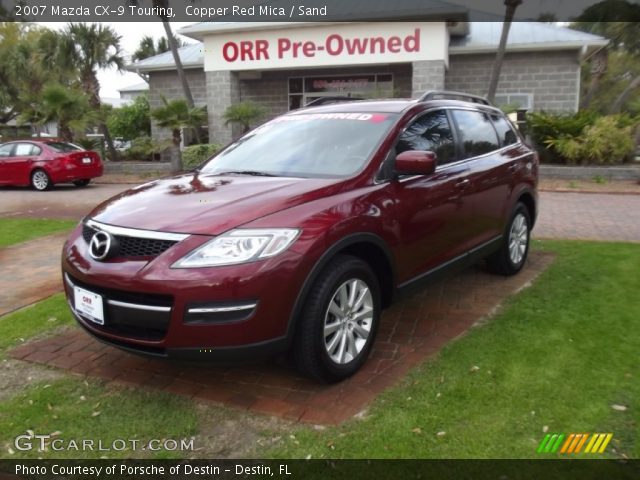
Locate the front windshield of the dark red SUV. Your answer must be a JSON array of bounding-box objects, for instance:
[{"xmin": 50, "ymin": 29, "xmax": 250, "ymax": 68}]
[{"xmin": 202, "ymin": 113, "xmax": 397, "ymax": 178}]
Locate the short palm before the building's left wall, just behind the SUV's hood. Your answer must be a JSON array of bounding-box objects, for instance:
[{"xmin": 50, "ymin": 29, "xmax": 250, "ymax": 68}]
[{"xmin": 151, "ymin": 97, "xmax": 207, "ymax": 172}]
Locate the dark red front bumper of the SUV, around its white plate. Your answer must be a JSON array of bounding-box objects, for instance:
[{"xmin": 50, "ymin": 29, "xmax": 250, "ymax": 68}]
[{"xmin": 62, "ymin": 228, "xmax": 306, "ymax": 360}]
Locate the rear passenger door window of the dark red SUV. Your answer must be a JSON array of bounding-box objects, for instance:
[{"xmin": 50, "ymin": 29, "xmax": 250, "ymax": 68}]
[{"xmin": 452, "ymin": 110, "xmax": 500, "ymax": 158}]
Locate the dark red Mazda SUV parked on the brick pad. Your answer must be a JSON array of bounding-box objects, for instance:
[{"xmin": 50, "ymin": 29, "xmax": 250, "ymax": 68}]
[{"xmin": 62, "ymin": 92, "xmax": 538, "ymax": 381}]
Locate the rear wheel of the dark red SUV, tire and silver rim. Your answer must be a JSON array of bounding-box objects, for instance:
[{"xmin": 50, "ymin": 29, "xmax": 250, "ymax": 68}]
[{"xmin": 487, "ymin": 202, "xmax": 531, "ymax": 276}]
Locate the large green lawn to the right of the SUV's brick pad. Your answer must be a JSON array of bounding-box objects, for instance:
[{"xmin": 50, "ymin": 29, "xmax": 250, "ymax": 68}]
[{"xmin": 270, "ymin": 241, "xmax": 640, "ymax": 458}]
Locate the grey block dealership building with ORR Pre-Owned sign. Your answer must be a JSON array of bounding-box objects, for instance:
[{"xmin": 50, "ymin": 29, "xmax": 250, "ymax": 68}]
[{"xmin": 128, "ymin": 12, "xmax": 607, "ymax": 149}]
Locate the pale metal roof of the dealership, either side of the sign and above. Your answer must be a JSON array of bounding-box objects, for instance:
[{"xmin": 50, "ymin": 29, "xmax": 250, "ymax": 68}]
[{"xmin": 126, "ymin": 22, "xmax": 608, "ymax": 72}]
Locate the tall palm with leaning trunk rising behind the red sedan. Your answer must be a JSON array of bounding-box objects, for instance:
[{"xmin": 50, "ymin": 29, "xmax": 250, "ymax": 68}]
[{"xmin": 60, "ymin": 23, "xmax": 124, "ymax": 161}]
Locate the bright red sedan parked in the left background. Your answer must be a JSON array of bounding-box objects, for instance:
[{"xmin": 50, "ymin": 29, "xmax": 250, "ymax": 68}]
[{"xmin": 0, "ymin": 138, "xmax": 103, "ymax": 191}]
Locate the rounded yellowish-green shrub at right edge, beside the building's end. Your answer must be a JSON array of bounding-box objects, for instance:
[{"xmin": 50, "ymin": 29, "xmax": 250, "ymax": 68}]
[{"xmin": 545, "ymin": 115, "xmax": 635, "ymax": 165}]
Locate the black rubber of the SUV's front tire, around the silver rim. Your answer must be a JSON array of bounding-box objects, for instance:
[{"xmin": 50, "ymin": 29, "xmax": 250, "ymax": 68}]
[{"xmin": 314, "ymin": 260, "xmax": 381, "ymax": 380}]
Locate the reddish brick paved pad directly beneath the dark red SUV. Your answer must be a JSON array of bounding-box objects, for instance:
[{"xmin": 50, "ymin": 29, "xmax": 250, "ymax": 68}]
[{"xmin": 10, "ymin": 252, "xmax": 553, "ymax": 424}]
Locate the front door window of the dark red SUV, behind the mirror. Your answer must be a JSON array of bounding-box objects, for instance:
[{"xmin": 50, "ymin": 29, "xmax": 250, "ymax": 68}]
[{"xmin": 396, "ymin": 110, "xmax": 455, "ymax": 165}]
